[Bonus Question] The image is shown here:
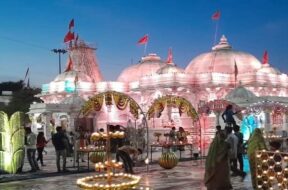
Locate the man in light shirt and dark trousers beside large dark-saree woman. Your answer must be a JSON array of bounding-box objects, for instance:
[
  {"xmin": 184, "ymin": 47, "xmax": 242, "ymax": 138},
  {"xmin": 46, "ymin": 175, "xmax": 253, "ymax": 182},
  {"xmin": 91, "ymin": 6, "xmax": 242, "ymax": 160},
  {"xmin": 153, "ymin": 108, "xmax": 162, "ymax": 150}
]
[{"xmin": 225, "ymin": 127, "xmax": 246, "ymax": 180}]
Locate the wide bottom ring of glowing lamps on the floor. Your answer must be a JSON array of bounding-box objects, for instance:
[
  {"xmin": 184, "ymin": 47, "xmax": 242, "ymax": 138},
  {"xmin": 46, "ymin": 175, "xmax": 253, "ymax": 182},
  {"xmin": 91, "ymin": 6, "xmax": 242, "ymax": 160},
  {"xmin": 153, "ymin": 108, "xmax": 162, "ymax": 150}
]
[{"xmin": 77, "ymin": 172, "xmax": 141, "ymax": 190}]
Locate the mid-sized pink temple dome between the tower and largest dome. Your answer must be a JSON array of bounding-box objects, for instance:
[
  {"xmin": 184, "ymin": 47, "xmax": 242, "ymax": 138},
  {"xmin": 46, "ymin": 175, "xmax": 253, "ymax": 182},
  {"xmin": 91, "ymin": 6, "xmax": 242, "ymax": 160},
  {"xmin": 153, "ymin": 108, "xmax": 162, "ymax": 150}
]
[{"xmin": 117, "ymin": 54, "xmax": 166, "ymax": 83}]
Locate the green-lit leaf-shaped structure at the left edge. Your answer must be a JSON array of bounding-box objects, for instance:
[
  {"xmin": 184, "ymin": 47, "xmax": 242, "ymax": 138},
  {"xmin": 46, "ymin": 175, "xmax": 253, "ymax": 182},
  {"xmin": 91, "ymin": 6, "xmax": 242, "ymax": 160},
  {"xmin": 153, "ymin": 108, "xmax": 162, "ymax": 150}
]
[{"xmin": 0, "ymin": 111, "xmax": 25, "ymax": 173}]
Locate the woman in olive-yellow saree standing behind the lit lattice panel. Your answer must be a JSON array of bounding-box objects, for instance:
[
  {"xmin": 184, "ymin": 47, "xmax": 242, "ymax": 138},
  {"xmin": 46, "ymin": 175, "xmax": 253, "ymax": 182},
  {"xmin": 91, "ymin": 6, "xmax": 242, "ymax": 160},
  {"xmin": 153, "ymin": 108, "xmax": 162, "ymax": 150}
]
[{"xmin": 247, "ymin": 128, "xmax": 267, "ymax": 189}]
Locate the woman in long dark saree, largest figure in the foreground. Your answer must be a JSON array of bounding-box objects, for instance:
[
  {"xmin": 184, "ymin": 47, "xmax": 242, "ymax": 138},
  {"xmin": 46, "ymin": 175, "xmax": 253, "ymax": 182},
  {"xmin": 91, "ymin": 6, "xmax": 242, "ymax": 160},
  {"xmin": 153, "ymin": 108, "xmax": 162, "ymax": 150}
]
[{"xmin": 204, "ymin": 131, "xmax": 232, "ymax": 190}]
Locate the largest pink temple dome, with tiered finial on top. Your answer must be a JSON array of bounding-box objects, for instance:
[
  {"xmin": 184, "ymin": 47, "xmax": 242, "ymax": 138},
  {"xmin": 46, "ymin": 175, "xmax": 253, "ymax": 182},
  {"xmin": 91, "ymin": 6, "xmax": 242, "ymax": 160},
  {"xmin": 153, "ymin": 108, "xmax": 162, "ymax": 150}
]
[{"xmin": 185, "ymin": 35, "xmax": 261, "ymax": 74}]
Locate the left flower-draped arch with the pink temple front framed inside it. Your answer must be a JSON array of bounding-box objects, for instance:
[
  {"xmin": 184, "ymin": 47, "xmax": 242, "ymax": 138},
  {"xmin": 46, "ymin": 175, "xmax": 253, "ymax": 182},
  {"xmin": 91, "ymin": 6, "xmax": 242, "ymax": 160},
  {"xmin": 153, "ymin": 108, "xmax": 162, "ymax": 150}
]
[{"xmin": 76, "ymin": 91, "xmax": 148, "ymax": 150}]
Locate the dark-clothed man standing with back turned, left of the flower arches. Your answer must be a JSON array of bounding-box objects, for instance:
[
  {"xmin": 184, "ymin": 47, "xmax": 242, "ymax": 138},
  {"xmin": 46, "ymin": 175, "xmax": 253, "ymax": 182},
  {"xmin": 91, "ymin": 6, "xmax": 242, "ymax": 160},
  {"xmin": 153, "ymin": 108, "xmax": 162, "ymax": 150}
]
[{"xmin": 52, "ymin": 127, "xmax": 68, "ymax": 172}]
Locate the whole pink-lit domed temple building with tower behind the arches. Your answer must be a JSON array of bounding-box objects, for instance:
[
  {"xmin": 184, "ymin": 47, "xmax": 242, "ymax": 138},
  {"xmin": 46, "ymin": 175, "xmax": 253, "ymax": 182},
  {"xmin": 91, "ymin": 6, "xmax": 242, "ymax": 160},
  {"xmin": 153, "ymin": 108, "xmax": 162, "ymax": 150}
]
[{"xmin": 29, "ymin": 35, "xmax": 288, "ymax": 154}]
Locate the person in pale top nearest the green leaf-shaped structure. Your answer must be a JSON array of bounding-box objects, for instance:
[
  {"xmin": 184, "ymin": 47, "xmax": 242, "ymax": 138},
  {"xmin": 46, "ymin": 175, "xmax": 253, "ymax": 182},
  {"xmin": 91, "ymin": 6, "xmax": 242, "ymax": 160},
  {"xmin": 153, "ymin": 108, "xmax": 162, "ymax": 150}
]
[{"xmin": 25, "ymin": 127, "xmax": 40, "ymax": 172}]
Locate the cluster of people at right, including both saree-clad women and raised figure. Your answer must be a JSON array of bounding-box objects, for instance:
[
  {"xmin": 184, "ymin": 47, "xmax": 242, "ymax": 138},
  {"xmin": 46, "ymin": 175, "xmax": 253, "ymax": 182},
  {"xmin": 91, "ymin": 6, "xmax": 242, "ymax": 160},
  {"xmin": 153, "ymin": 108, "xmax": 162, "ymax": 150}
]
[{"xmin": 204, "ymin": 105, "xmax": 267, "ymax": 190}]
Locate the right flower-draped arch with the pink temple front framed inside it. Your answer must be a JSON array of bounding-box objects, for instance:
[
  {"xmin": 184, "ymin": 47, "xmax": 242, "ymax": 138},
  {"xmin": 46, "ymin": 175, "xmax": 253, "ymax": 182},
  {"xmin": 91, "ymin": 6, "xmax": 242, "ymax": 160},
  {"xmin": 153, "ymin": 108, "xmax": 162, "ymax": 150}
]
[{"xmin": 147, "ymin": 95, "xmax": 202, "ymax": 156}]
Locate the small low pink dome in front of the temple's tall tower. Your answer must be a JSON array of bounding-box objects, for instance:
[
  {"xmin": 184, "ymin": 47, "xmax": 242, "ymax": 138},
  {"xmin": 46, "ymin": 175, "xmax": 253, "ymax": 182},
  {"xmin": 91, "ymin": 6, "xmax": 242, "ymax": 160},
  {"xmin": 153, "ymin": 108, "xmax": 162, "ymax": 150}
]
[{"xmin": 53, "ymin": 70, "xmax": 93, "ymax": 82}]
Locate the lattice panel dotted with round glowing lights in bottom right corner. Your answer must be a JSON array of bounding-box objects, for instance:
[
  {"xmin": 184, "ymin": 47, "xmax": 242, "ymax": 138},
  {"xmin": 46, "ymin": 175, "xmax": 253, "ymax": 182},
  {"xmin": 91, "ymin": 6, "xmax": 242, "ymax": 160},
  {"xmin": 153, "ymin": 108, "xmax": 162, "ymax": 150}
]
[{"xmin": 256, "ymin": 150, "xmax": 288, "ymax": 190}]
